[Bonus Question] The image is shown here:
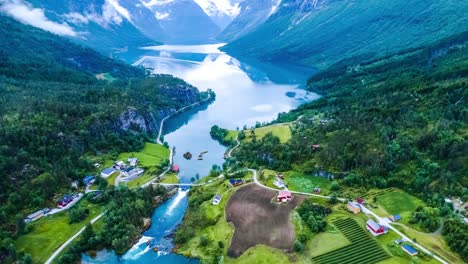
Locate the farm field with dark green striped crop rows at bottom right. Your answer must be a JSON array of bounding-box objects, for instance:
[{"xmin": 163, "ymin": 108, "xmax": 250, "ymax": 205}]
[{"xmin": 312, "ymin": 218, "xmax": 390, "ymax": 264}]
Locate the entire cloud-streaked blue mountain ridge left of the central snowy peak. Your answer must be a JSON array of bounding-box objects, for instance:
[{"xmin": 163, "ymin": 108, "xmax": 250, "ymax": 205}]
[{"xmin": 0, "ymin": 0, "xmax": 223, "ymax": 53}]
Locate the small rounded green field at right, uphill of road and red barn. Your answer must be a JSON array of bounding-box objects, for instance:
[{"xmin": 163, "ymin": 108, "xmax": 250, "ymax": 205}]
[{"xmin": 377, "ymin": 190, "xmax": 424, "ymax": 224}]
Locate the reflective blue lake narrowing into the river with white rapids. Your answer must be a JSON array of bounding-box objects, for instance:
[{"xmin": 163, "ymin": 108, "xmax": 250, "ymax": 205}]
[{"xmin": 82, "ymin": 44, "xmax": 318, "ymax": 264}]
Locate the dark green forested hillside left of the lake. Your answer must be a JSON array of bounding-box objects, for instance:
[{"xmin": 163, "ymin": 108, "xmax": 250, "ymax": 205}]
[{"xmin": 0, "ymin": 16, "xmax": 205, "ymax": 262}]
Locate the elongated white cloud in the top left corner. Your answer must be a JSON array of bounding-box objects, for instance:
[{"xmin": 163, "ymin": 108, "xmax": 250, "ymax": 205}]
[{"xmin": 0, "ymin": 0, "xmax": 78, "ymax": 37}]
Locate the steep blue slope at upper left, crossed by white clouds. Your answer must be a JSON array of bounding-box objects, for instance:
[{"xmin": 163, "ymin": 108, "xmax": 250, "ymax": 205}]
[{"xmin": 0, "ymin": 0, "xmax": 162, "ymax": 53}]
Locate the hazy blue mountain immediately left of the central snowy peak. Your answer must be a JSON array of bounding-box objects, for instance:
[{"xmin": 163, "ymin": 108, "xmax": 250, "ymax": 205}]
[{"xmin": 145, "ymin": 0, "xmax": 220, "ymax": 44}]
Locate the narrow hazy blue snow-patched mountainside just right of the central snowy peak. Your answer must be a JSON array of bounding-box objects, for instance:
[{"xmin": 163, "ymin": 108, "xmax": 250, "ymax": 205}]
[{"xmin": 218, "ymin": 0, "xmax": 281, "ymax": 42}]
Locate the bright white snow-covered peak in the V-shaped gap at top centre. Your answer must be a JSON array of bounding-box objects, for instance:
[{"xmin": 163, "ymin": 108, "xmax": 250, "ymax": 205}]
[{"xmin": 194, "ymin": 0, "xmax": 244, "ymax": 30}]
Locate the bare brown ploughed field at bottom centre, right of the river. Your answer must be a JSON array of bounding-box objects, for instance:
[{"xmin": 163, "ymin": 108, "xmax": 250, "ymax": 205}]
[{"xmin": 226, "ymin": 184, "xmax": 304, "ymax": 257}]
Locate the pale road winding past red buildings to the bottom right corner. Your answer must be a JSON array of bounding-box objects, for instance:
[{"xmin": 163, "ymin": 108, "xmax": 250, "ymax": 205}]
[{"xmin": 249, "ymin": 169, "xmax": 448, "ymax": 264}]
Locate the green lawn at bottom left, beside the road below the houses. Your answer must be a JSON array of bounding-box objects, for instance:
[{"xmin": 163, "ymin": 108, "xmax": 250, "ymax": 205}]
[{"xmin": 16, "ymin": 197, "xmax": 102, "ymax": 263}]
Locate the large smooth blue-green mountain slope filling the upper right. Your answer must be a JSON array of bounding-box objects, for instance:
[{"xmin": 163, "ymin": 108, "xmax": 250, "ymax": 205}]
[{"xmin": 222, "ymin": 0, "xmax": 468, "ymax": 68}]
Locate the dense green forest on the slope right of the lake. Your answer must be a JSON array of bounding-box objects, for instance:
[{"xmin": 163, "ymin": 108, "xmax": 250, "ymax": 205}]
[{"xmin": 234, "ymin": 34, "xmax": 468, "ymax": 260}]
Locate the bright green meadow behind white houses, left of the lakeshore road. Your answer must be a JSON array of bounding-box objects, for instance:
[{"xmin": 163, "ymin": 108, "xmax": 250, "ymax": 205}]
[{"xmin": 119, "ymin": 142, "xmax": 170, "ymax": 167}]
